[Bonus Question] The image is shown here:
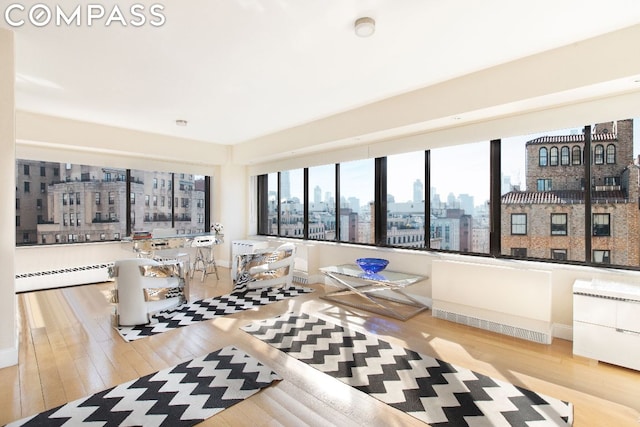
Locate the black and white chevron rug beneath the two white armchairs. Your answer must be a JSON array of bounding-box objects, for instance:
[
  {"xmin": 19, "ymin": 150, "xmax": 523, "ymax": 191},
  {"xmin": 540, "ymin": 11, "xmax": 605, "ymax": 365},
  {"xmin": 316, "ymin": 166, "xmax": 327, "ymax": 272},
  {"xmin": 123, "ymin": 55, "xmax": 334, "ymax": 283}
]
[{"xmin": 116, "ymin": 286, "xmax": 313, "ymax": 341}]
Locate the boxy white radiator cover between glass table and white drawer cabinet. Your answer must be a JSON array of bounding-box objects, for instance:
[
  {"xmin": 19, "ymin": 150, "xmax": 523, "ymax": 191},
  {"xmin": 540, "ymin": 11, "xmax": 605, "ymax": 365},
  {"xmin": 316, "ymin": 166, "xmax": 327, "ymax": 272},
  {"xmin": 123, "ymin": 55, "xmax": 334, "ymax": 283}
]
[{"xmin": 431, "ymin": 260, "xmax": 553, "ymax": 344}]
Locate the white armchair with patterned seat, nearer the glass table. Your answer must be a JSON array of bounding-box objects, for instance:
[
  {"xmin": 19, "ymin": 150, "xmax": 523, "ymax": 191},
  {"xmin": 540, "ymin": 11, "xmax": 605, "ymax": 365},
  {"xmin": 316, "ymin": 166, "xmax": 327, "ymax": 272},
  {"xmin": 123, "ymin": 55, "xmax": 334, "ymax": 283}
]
[{"xmin": 235, "ymin": 243, "xmax": 296, "ymax": 289}]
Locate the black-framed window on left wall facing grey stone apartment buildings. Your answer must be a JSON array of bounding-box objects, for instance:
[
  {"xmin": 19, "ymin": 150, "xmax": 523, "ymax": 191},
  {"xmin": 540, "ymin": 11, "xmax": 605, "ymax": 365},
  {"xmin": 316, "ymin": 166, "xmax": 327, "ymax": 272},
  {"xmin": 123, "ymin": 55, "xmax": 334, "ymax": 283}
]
[{"xmin": 16, "ymin": 159, "xmax": 209, "ymax": 245}]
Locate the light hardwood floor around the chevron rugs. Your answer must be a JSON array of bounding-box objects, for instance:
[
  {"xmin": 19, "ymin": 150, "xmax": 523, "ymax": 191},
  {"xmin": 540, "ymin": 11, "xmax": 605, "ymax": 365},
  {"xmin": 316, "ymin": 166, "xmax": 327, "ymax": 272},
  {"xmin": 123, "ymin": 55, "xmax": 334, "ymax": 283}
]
[{"xmin": 0, "ymin": 268, "xmax": 640, "ymax": 427}]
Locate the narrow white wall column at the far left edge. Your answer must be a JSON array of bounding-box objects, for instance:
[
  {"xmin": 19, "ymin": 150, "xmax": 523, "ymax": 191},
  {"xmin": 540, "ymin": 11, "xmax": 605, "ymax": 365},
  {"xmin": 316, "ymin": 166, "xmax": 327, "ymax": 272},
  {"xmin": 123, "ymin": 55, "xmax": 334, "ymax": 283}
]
[{"xmin": 0, "ymin": 28, "xmax": 18, "ymax": 368}]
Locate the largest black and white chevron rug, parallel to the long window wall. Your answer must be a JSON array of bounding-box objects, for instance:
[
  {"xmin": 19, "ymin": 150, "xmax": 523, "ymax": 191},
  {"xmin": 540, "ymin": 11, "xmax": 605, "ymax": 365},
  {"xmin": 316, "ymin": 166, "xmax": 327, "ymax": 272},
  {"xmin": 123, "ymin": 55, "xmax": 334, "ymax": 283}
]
[{"xmin": 242, "ymin": 313, "xmax": 573, "ymax": 426}]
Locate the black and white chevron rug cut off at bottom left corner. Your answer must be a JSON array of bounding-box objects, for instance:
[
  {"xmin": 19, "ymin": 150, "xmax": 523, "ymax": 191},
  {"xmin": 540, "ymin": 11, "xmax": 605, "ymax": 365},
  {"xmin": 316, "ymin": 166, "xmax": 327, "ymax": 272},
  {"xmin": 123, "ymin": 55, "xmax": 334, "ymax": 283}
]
[{"xmin": 7, "ymin": 347, "xmax": 281, "ymax": 427}]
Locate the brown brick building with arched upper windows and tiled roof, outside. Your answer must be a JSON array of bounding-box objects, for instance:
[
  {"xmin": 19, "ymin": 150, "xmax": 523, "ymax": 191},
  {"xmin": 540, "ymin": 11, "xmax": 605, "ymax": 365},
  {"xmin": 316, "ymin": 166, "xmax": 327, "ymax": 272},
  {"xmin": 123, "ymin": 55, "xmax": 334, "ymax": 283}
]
[{"xmin": 501, "ymin": 120, "xmax": 640, "ymax": 266}]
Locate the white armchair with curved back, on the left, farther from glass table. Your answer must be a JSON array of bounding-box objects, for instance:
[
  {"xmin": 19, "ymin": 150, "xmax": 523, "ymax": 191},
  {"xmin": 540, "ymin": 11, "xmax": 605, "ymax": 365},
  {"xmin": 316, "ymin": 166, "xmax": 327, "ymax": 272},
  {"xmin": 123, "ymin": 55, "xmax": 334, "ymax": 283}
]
[{"xmin": 113, "ymin": 258, "xmax": 185, "ymax": 326}]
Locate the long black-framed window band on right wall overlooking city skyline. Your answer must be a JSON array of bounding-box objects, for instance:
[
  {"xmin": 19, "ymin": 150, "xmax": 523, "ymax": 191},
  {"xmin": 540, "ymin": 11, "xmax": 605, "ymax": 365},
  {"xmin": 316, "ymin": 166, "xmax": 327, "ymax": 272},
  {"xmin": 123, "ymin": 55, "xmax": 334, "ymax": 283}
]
[{"xmin": 256, "ymin": 119, "xmax": 640, "ymax": 269}]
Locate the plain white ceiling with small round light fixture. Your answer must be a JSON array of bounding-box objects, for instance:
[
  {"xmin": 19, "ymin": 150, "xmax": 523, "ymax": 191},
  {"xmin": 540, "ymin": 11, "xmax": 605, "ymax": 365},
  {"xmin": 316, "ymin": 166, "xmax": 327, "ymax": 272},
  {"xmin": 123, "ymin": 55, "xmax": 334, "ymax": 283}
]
[{"xmin": 0, "ymin": 0, "xmax": 640, "ymax": 144}]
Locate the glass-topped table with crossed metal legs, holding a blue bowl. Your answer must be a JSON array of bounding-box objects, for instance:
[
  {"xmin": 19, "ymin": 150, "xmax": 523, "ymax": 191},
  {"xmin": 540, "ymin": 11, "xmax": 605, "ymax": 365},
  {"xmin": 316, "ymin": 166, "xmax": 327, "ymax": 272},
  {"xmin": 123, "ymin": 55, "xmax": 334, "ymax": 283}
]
[{"xmin": 320, "ymin": 264, "xmax": 429, "ymax": 320}]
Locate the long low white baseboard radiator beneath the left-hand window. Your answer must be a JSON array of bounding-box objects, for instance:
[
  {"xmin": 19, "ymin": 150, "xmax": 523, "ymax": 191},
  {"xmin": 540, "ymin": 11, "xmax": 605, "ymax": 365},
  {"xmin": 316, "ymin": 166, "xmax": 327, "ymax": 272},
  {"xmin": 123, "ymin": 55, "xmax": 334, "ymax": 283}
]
[{"xmin": 15, "ymin": 263, "xmax": 113, "ymax": 292}]
